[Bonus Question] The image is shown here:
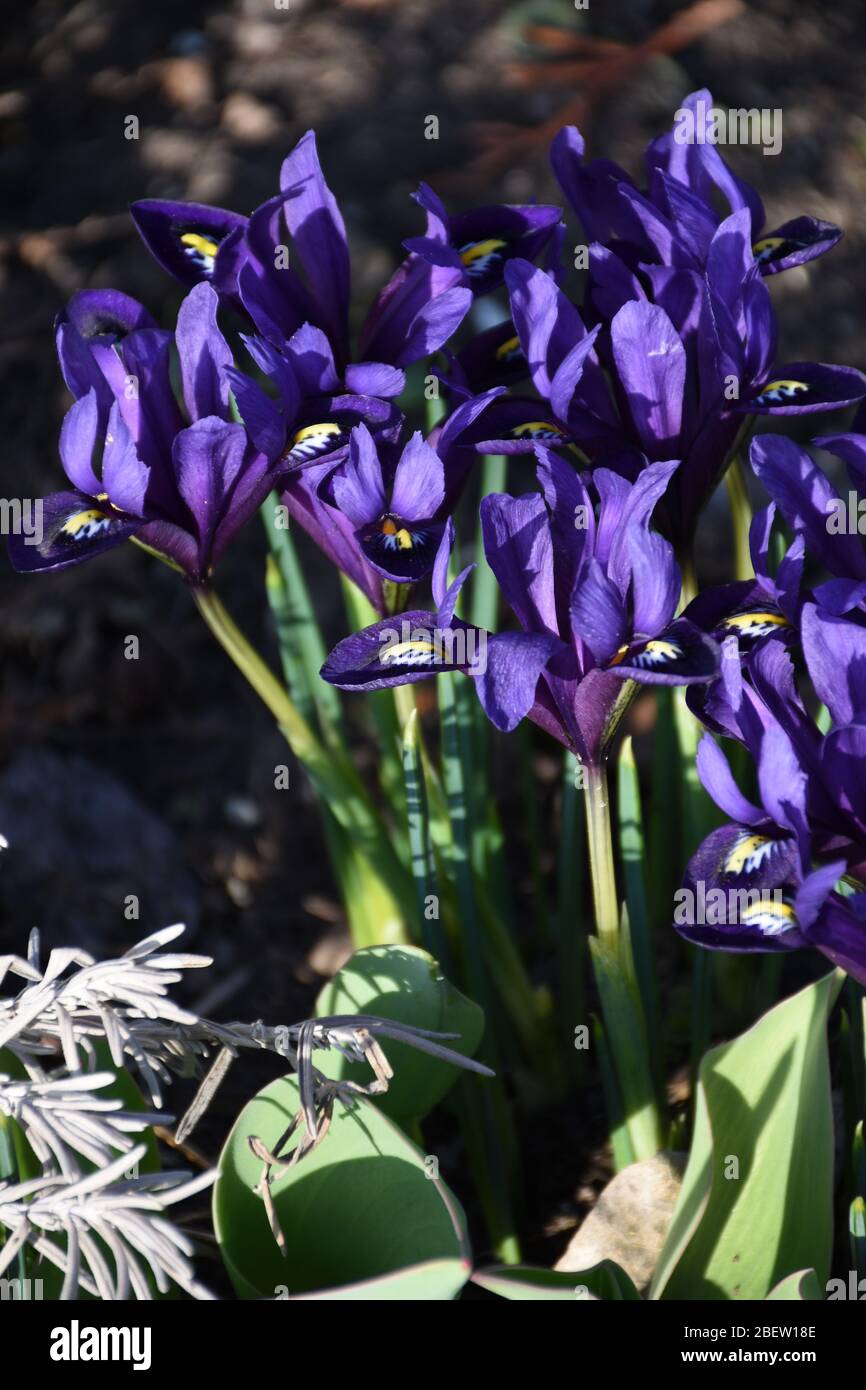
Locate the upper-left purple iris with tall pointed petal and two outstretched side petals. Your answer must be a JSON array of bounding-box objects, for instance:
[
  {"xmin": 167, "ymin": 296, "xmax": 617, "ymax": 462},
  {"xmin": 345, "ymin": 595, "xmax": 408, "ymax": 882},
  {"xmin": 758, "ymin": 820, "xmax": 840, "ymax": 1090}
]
[{"xmin": 132, "ymin": 131, "xmax": 562, "ymax": 395}]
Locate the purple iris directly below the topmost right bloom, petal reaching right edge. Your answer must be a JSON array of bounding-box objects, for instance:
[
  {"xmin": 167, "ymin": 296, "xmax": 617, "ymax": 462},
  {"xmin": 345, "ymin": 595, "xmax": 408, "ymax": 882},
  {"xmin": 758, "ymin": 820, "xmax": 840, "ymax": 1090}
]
[{"xmin": 478, "ymin": 239, "xmax": 866, "ymax": 549}]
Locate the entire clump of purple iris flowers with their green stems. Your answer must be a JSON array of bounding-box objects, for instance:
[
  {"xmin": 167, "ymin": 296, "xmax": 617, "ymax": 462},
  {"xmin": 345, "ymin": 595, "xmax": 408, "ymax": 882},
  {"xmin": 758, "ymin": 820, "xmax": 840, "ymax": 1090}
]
[{"xmin": 10, "ymin": 92, "xmax": 866, "ymax": 1228}]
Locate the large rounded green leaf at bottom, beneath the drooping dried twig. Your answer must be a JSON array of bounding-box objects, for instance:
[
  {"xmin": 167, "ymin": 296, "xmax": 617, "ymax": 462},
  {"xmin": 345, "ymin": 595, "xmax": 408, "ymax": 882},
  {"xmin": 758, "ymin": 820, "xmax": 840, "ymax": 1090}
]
[{"xmin": 213, "ymin": 1077, "xmax": 471, "ymax": 1301}]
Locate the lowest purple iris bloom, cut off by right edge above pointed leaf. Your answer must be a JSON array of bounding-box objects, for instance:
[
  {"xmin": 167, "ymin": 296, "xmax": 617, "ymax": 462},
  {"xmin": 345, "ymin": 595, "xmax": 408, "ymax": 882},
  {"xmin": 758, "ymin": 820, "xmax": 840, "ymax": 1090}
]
[{"xmin": 674, "ymin": 602, "xmax": 866, "ymax": 981}]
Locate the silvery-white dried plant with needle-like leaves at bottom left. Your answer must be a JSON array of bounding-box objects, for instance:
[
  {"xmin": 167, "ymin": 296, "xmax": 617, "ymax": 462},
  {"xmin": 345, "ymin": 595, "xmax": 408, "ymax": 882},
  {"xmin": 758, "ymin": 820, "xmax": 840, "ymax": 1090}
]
[{"xmin": 0, "ymin": 926, "xmax": 489, "ymax": 1300}]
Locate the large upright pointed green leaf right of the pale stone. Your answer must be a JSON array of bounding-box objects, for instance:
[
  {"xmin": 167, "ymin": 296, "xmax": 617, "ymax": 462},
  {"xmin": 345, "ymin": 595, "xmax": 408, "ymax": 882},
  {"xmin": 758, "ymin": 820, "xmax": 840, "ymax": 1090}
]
[{"xmin": 651, "ymin": 973, "xmax": 840, "ymax": 1300}]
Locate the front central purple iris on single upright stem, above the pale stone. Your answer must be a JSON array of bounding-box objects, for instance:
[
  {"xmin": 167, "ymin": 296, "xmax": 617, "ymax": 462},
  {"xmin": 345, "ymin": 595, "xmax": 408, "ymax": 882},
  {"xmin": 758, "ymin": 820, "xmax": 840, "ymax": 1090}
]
[{"xmin": 321, "ymin": 445, "xmax": 717, "ymax": 766}]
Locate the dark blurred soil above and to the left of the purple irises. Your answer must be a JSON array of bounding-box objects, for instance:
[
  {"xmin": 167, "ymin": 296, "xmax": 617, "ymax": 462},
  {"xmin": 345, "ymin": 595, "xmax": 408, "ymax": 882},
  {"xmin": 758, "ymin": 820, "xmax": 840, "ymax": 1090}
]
[{"xmin": 0, "ymin": 0, "xmax": 866, "ymax": 1262}]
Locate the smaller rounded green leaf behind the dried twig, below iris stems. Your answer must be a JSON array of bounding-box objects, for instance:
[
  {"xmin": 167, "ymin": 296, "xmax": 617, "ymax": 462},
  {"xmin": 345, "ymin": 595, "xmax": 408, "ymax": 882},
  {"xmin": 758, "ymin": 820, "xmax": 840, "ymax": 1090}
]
[{"xmin": 316, "ymin": 947, "xmax": 484, "ymax": 1120}]
